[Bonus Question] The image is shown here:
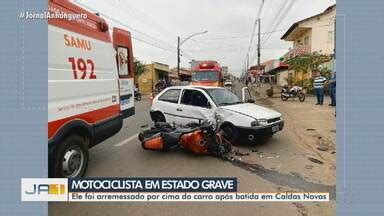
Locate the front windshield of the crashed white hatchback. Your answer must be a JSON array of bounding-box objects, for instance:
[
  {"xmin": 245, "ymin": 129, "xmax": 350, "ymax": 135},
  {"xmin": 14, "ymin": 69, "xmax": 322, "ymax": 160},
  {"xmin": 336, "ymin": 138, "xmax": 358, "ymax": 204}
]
[{"xmin": 207, "ymin": 88, "xmax": 243, "ymax": 106}]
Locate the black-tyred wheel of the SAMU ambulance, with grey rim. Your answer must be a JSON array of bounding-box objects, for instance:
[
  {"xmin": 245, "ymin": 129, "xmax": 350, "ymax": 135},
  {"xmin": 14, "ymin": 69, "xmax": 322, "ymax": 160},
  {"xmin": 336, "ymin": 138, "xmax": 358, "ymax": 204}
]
[{"xmin": 54, "ymin": 134, "xmax": 89, "ymax": 178}]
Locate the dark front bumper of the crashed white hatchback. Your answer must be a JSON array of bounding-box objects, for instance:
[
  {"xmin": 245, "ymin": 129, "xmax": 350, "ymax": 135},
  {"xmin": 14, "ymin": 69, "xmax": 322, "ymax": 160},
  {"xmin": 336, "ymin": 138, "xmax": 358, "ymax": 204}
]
[{"xmin": 235, "ymin": 120, "xmax": 284, "ymax": 144}]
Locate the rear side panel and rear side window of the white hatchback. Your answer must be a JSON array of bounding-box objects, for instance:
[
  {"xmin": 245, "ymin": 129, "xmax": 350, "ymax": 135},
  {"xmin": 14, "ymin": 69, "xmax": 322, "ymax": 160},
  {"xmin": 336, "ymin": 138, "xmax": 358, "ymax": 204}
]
[{"xmin": 156, "ymin": 89, "xmax": 181, "ymax": 123}]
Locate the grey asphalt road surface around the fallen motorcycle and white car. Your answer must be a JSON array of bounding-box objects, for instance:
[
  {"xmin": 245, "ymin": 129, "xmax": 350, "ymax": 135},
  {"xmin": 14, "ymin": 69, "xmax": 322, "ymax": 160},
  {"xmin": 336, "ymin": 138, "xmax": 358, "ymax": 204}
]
[{"xmin": 49, "ymin": 83, "xmax": 335, "ymax": 216}]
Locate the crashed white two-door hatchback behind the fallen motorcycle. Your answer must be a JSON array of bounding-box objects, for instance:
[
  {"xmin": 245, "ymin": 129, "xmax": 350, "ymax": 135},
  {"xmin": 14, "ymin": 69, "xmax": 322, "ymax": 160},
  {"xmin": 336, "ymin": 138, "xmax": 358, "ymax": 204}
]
[{"xmin": 150, "ymin": 86, "xmax": 284, "ymax": 144}]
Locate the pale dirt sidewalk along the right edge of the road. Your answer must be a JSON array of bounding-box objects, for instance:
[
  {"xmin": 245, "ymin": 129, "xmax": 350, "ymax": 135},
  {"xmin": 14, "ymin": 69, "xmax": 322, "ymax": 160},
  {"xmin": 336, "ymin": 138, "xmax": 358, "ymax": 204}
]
[{"xmin": 250, "ymin": 84, "xmax": 336, "ymax": 166}]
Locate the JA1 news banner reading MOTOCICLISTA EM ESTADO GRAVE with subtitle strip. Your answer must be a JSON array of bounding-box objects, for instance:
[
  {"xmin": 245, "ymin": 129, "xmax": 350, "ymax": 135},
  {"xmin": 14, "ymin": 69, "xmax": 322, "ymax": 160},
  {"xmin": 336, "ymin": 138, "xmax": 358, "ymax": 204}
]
[{"xmin": 21, "ymin": 177, "xmax": 329, "ymax": 202}]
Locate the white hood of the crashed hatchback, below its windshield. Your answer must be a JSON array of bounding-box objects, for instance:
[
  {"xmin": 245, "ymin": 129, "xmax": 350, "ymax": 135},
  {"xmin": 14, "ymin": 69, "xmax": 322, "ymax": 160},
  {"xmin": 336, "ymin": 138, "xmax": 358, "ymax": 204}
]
[{"xmin": 220, "ymin": 103, "xmax": 281, "ymax": 119}]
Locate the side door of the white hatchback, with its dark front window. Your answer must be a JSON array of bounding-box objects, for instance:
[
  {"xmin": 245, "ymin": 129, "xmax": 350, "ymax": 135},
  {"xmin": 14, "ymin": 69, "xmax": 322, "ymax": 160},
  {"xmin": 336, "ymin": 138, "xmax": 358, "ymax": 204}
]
[{"xmin": 177, "ymin": 89, "xmax": 214, "ymax": 124}]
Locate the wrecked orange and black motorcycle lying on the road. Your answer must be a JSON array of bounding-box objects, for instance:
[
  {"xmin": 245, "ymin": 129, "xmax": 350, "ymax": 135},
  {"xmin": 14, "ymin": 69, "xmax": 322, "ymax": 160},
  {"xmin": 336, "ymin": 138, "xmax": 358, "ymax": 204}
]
[{"xmin": 139, "ymin": 121, "xmax": 232, "ymax": 158}]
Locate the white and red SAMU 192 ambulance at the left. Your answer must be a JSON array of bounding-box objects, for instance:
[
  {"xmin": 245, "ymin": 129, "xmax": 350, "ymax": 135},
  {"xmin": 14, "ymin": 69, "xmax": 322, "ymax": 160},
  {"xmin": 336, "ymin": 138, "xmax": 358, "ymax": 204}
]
[{"xmin": 48, "ymin": 0, "xmax": 135, "ymax": 178}]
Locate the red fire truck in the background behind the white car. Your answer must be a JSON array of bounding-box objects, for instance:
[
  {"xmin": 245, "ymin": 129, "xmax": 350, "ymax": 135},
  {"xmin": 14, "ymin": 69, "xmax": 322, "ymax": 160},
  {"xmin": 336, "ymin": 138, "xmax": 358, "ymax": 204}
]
[{"xmin": 192, "ymin": 61, "xmax": 224, "ymax": 87}]
